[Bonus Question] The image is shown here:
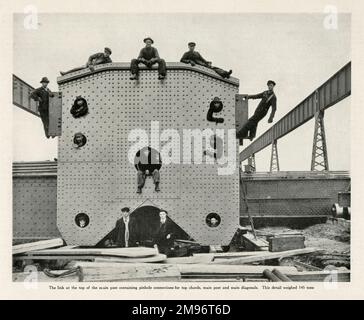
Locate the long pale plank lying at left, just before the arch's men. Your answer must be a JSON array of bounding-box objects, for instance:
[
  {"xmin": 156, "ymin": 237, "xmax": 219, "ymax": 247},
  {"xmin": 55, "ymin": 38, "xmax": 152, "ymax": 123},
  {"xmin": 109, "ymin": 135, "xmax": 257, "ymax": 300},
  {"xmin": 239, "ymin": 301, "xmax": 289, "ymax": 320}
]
[{"xmin": 30, "ymin": 247, "xmax": 159, "ymax": 258}]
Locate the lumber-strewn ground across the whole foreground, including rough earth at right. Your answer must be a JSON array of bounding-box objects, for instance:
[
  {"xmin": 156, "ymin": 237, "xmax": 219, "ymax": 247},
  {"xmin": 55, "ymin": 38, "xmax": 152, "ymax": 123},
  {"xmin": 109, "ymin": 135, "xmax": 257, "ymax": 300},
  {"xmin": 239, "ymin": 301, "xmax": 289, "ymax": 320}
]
[{"xmin": 13, "ymin": 219, "xmax": 350, "ymax": 282}]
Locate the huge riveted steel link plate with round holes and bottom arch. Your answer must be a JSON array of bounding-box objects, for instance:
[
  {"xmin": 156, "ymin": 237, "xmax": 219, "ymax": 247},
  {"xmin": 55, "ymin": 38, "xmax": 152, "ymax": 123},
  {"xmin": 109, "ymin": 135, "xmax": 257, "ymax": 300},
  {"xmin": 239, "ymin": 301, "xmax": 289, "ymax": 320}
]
[{"xmin": 57, "ymin": 63, "xmax": 239, "ymax": 245}]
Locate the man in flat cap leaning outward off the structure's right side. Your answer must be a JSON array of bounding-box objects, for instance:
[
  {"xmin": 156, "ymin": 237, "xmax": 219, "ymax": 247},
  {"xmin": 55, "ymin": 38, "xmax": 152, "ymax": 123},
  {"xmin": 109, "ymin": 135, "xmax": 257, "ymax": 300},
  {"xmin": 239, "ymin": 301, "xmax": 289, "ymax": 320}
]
[{"xmin": 237, "ymin": 80, "xmax": 277, "ymax": 140}]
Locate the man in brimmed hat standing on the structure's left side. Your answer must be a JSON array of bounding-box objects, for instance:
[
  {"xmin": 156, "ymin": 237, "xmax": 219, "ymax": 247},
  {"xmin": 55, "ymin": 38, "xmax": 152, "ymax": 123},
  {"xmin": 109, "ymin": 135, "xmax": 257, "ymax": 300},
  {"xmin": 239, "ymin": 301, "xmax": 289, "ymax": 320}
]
[{"xmin": 30, "ymin": 77, "xmax": 54, "ymax": 139}]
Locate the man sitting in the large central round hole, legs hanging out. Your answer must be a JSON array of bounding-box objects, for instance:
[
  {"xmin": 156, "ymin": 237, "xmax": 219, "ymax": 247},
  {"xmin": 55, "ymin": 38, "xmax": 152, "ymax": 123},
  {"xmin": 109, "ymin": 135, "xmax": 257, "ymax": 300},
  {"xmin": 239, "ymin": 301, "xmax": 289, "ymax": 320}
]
[{"xmin": 135, "ymin": 147, "xmax": 162, "ymax": 193}]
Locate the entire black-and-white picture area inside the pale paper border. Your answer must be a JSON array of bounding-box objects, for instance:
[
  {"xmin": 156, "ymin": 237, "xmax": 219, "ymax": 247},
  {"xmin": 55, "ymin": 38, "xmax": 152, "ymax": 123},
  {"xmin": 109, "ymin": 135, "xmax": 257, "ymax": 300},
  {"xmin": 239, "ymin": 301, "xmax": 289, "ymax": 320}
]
[{"xmin": 0, "ymin": 1, "xmax": 361, "ymax": 297}]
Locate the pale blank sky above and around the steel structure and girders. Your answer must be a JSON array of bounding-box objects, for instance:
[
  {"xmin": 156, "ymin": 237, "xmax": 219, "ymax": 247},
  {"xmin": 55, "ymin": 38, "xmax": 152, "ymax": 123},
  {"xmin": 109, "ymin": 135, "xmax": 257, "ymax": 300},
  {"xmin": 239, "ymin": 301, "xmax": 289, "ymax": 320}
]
[{"xmin": 13, "ymin": 13, "xmax": 351, "ymax": 171}]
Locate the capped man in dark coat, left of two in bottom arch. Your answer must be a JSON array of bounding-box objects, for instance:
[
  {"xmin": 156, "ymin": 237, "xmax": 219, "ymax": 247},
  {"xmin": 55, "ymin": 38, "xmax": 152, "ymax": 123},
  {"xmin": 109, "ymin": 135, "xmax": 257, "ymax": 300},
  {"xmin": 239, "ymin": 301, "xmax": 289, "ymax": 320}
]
[{"xmin": 107, "ymin": 207, "xmax": 139, "ymax": 248}]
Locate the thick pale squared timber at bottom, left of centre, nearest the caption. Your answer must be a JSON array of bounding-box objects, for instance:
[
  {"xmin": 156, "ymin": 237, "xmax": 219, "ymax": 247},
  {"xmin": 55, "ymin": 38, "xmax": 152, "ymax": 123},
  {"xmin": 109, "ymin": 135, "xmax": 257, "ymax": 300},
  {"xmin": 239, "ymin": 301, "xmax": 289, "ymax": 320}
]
[{"xmin": 77, "ymin": 262, "xmax": 181, "ymax": 282}]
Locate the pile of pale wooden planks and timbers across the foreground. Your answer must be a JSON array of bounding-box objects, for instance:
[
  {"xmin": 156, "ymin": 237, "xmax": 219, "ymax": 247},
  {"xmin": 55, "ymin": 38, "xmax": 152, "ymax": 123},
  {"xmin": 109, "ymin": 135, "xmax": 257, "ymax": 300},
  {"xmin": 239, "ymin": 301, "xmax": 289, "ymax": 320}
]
[{"xmin": 13, "ymin": 239, "xmax": 350, "ymax": 282}]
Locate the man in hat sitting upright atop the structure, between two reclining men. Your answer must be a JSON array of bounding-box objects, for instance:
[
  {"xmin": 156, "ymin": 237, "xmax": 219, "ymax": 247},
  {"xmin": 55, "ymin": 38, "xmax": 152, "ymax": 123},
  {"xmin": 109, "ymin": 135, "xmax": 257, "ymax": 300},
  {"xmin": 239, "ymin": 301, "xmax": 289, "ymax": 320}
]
[{"xmin": 130, "ymin": 37, "xmax": 167, "ymax": 80}]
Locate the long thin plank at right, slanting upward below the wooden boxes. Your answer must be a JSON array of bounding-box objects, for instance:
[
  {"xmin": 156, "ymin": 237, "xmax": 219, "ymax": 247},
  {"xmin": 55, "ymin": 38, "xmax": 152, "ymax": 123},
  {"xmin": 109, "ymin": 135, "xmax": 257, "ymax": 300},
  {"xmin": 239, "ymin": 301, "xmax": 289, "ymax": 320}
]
[{"xmin": 211, "ymin": 248, "xmax": 322, "ymax": 265}]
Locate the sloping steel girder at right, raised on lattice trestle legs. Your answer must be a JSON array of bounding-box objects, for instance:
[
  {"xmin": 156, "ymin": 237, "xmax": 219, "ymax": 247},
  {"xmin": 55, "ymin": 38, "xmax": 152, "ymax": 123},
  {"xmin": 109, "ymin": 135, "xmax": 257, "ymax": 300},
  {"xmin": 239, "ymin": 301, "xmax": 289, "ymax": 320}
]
[{"xmin": 240, "ymin": 62, "xmax": 351, "ymax": 161}]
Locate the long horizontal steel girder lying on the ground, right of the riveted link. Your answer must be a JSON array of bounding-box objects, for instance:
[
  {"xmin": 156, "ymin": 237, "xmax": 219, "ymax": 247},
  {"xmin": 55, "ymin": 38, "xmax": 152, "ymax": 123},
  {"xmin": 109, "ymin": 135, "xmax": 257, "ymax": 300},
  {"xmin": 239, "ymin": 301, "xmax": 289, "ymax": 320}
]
[{"xmin": 240, "ymin": 171, "xmax": 350, "ymax": 220}]
